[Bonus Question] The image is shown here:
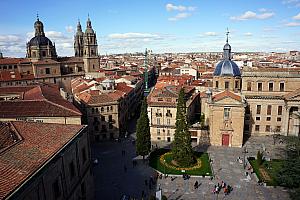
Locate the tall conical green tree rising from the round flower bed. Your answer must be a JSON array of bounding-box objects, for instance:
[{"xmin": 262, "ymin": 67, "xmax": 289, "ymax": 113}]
[{"xmin": 172, "ymin": 88, "xmax": 194, "ymax": 167}]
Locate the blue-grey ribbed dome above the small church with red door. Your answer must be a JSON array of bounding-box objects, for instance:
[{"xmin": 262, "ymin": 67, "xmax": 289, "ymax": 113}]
[{"xmin": 214, "ymin": 59, "xmax": 241, "ymax": 77}]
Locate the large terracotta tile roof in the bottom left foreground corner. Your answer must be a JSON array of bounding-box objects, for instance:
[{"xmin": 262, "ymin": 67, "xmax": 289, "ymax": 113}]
[{"xmin": 0, "ymin": 122, "xmax": 84, "ymax": 199}]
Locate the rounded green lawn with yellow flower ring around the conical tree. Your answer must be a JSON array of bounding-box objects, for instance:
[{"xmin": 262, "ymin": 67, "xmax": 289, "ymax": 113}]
[{"xmin": 150, "ymin": 149, "xmax": 212, "ymax": 176}]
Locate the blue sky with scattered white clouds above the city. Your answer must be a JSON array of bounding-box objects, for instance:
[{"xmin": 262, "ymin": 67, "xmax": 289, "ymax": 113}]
[{"xmin": 0, "ymin": 0, "xmax": 300, "ymax": 57}]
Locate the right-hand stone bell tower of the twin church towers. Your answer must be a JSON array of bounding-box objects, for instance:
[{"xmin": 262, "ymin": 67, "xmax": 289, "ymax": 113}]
[{"xmin": 83, "ymin": 17, "xmax": 100, "ymax": 72}]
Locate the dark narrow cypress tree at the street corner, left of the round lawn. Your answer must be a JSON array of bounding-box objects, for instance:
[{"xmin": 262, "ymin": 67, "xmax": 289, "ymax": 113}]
[{"xmin": 136, "ymin": 97, "xmax": 151, "ymax": 159}]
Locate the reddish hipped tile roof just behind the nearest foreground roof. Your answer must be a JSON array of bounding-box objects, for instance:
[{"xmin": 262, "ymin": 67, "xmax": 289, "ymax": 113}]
[{"xmin": 0, "ymin": 84, "xmax": 82, "ymax": 118}]
